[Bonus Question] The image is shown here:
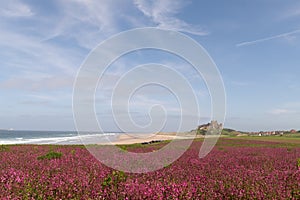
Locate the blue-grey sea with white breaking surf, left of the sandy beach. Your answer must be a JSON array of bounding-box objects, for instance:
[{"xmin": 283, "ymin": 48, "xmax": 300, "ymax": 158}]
[{"xmin": 0, "ymin": 130, "xmax": 121, "ymax": 145}]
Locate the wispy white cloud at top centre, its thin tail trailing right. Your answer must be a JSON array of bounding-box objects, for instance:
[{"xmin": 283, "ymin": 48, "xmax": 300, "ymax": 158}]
[{"xmin": 134, "ymin": 0, "xmax": 209, "ymax": 35}]
